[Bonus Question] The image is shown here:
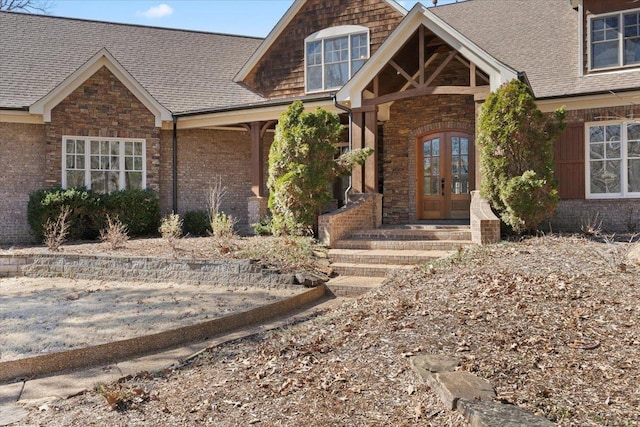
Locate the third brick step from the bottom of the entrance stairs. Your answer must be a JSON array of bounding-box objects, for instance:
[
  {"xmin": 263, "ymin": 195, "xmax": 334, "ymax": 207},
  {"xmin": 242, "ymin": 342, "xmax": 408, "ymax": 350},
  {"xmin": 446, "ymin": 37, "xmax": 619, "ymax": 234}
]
[{"xmin": 328, "ymin": 249, "xmax": 451, "ymax": 268}]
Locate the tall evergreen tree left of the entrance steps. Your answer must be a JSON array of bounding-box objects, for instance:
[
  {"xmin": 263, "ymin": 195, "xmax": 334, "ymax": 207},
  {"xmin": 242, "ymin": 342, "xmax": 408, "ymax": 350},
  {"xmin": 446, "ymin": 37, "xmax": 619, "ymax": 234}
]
[{"xmin": 267, "ymin": 101, "xmax": 373, "ymax": 235}]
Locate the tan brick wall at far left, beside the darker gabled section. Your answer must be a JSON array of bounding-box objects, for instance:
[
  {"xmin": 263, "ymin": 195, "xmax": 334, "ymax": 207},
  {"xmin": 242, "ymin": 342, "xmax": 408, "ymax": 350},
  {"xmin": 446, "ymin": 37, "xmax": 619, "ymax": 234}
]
[{"xmin": 0, "ymin": 123, "xmax": 45, "ymax": 246}]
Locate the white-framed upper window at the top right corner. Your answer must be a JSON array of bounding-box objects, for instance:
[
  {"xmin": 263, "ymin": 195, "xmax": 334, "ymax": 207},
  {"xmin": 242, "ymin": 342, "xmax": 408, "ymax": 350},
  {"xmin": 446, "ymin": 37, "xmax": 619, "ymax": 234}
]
[{"xmin": 589, "ymin": 9, "xmax": 640, "ymax": 70}]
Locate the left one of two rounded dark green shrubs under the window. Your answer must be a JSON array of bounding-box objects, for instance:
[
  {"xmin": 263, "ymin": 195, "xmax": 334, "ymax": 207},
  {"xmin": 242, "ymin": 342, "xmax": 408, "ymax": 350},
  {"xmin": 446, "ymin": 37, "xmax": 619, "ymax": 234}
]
[{"xmin": 27, "ymin": 188, "xmax": 100, "ymax": 240}]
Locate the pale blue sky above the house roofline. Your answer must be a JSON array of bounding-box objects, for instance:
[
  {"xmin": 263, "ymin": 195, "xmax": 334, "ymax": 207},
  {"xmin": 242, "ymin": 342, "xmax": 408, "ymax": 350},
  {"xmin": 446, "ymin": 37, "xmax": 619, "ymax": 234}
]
[{"xmin": 49, "ymin": 0, "xmax": 455, "ymax": 37}]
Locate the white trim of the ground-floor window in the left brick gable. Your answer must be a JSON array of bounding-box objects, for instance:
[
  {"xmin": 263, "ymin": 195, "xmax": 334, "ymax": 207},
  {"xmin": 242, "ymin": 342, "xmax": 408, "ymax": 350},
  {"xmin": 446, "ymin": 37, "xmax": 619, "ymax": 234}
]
[{"xmin": 61, "ymin": 135, "xmax": 147, "ymax": 190}]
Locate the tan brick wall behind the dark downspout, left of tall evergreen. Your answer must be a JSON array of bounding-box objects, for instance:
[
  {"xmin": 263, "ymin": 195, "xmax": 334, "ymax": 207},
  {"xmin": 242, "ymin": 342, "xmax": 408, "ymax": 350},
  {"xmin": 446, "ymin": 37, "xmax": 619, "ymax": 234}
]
[{"xmin": 160, "ymin": 129, "xmax": 273, "ymax": 232}]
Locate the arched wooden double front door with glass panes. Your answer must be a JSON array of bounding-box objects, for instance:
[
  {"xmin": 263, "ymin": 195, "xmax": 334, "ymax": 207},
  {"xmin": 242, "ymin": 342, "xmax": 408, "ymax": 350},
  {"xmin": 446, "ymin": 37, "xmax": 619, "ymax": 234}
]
[{"xmin": 416, "ymin": 131, "xmax": 475, "ymax": 219}]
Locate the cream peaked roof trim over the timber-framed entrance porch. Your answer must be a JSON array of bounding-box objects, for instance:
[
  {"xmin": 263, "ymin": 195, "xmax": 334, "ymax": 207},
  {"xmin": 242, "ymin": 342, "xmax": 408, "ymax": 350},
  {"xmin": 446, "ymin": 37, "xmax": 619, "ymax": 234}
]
[{"xmin": 336, "ymin": 3, "xmax": 518, "ymax": 108}]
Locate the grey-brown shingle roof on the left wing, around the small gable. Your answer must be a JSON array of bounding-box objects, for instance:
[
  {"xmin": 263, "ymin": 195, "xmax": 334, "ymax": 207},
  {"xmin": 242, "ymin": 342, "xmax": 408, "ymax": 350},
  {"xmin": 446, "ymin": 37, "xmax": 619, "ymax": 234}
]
[{"xmin": 0, "ymin": 12, "xmax": 264, "ymax": 112}]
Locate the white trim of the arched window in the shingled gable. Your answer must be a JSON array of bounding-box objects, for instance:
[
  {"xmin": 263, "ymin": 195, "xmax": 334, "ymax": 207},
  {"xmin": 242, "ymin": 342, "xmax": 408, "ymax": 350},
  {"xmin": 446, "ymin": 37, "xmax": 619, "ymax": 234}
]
[{"xmin": 304, "ymin": 25, "xmax": 371, "ymax": 93}]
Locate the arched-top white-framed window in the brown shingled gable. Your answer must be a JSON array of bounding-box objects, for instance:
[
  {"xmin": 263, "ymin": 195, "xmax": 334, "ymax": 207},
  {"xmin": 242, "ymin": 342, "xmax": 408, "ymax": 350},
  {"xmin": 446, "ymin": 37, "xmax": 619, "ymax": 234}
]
[{"xmin": 304, "ymin": 25, "xmax": 369, "ymax": 92}]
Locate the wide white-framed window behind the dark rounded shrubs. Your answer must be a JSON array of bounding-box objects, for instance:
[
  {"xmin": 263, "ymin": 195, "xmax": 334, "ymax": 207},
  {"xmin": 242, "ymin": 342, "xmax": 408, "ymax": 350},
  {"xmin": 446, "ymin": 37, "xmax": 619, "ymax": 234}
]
[{"xmin": 62, "ymin": 136, "xmax": 147, "ymax": 193}]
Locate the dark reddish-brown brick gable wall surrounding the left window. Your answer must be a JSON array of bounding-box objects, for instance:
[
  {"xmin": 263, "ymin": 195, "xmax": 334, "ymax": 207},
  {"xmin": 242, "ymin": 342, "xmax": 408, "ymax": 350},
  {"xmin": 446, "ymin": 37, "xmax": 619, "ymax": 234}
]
[{"xmin": 45, "ymin": 67, "xmax": 160, "ymax": 192}]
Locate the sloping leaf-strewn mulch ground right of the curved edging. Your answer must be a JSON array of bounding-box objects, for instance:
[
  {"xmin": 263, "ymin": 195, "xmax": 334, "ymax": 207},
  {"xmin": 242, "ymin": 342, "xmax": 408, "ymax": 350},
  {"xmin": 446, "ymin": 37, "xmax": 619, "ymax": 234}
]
[{"xmin": 11, "ymin": 236, "xmax": 640, "ymax": 427}]
